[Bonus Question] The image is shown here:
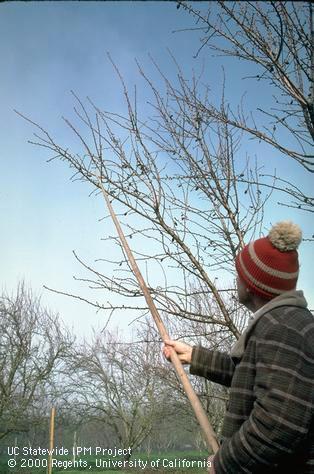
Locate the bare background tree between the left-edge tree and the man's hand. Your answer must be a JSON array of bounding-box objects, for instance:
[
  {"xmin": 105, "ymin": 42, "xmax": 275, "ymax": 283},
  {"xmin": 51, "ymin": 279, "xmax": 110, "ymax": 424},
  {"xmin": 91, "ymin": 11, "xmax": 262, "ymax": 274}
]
[{"xmin": 67, "ymin": 333, "xmax": 174, "ymax": 459}]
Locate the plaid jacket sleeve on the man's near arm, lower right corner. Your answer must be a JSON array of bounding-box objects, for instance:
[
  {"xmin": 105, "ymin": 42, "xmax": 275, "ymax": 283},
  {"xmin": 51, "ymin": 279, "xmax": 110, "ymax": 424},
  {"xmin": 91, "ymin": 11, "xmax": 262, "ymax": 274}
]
[{"xmin": 214, "ymin": 324, "xmax": 314, "ymax": 474}]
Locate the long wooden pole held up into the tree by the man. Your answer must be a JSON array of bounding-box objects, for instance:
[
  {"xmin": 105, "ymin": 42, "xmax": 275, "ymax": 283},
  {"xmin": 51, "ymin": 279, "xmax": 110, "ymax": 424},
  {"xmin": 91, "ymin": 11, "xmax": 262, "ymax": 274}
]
[{"xmin": 99, "ymin": 179, "xmax": 219, "ymax": 453}]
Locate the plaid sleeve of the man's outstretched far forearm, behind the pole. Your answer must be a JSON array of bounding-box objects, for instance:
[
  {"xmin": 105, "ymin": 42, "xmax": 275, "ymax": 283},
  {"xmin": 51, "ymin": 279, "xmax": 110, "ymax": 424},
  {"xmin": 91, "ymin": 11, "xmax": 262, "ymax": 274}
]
[{"xmin": 190, "ymin": 346, "xmax": 235, "ymax": 387}]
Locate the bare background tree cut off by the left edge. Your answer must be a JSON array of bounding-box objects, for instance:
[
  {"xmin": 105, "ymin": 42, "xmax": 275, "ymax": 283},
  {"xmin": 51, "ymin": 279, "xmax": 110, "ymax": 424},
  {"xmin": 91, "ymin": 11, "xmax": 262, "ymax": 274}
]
[{"xmin": 0, "ymin": 284, "xmax": 71, "ymax": 439}]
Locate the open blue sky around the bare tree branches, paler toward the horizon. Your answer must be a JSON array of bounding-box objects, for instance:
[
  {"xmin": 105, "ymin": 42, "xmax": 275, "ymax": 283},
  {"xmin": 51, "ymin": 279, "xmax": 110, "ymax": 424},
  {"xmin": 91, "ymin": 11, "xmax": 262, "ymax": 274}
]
[{"xmin": 0, "ymin": 2, "xmax": 314, "ymax": 334}]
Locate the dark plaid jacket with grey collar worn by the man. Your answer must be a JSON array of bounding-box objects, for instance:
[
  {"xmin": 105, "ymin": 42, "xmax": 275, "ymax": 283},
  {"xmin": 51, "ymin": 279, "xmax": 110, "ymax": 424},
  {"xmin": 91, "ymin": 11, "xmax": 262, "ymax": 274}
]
[{"xmin": 190, "ymin": 291, "xmax": 314, "ymax": 474}]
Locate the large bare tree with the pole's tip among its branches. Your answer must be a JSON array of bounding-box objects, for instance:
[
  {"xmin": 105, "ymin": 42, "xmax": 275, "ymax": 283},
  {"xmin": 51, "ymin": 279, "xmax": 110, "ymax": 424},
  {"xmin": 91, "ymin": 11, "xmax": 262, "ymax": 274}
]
[{"xmin": 17, "ymin": 51, "xmax": 271, "ymax": 337}]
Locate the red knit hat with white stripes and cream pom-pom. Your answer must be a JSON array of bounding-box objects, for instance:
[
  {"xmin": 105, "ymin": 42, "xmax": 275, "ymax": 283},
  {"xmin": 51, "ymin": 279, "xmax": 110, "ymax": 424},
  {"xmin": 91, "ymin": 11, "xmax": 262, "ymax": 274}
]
[{"xmin": 235, "ymin": 221, "xmax": 302, "ymax": 299}]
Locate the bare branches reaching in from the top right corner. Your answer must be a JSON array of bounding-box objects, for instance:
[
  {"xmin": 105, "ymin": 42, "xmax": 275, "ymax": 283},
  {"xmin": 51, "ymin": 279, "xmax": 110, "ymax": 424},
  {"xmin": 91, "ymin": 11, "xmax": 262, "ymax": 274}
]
[{"xmin": 178, "ymin": 0, "xmax": 314, "ymax": 212}]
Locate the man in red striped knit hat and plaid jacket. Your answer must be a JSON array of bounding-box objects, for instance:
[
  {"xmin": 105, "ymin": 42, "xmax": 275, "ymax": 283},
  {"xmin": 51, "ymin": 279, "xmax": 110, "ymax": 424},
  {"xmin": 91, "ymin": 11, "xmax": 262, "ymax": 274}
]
[{"xmin": 164, "ymin": 222, "xmax": 314, "ymax": 474}]
